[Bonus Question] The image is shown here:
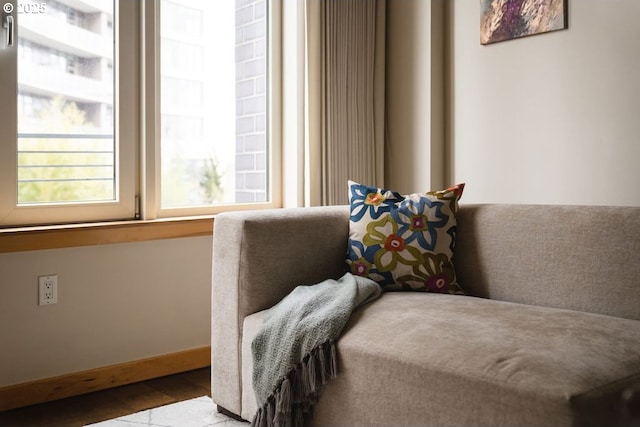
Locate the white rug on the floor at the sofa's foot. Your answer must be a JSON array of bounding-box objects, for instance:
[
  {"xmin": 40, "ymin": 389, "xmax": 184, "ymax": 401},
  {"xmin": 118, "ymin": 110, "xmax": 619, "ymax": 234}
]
[{"xmin": 89, "ymin": 396, "xmax": 249, "ymax": 427}]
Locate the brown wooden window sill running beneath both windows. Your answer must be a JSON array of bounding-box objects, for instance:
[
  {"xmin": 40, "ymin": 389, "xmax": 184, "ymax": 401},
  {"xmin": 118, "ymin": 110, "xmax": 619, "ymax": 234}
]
[{"xmin": 0, "ymin": 216, "xmax": 213, "ymax": 253}]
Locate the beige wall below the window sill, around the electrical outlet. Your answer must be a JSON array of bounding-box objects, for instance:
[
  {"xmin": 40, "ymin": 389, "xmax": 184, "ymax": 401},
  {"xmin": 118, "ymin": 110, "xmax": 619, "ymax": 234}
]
[{"xmin": 0, "ymin": 237, "xmax": 212, "ymax": 387}]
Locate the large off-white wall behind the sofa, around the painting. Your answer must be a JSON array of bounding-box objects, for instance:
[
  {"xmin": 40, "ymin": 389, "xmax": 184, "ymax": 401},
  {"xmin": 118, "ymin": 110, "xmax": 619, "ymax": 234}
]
[{"xmin": 448, "ymin": 0, "xmax": 640, "ymax": 206}]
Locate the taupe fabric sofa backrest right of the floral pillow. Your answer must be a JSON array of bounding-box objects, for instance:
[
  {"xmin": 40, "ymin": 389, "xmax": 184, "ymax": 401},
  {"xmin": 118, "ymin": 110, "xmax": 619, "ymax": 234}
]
[{"xmin": 454, "ymin": 204, "xmax": 640, "ymax": 320}]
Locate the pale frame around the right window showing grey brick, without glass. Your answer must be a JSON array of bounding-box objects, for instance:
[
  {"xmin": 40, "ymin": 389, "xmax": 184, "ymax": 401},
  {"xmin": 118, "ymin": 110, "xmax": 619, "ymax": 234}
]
[{"xmin": 141, "ymin": 0, "xmax": 282, "ymax": 220}]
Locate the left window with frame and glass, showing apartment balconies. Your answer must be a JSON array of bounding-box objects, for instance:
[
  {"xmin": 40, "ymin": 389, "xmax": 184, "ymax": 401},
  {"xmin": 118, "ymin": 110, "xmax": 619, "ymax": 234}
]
[{"xmin": 0, "ymin": 0, "xmax": 136, "ymax": 226}]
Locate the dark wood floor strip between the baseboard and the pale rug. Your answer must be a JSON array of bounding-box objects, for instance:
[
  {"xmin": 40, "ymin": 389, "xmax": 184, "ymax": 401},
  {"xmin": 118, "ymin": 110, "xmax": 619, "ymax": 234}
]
[{"xmin": 0, "ymin": 368, "xmax": 211, "ymax": 427}]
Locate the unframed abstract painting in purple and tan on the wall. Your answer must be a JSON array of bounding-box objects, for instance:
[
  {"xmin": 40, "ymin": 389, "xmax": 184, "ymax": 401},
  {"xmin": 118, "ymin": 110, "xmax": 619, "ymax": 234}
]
[{"xmin": 480, "ymin": 0, "xmax": 568, "ymax": 45}]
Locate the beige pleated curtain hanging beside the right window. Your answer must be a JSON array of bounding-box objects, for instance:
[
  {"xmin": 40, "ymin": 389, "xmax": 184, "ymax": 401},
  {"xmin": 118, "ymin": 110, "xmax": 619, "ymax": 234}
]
[{"xmin": 304, "ymin": 0, "xmax": 385, "ymax": 206}]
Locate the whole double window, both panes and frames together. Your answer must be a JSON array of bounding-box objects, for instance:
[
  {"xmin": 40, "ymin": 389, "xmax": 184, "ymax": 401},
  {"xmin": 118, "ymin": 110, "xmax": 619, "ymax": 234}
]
[{"xmin": 0, "ymin": 0, "xmax": 279, "ymax": 227}]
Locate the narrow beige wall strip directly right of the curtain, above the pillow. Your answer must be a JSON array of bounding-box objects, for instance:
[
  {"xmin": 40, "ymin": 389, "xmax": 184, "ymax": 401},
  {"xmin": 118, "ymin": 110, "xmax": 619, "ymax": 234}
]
[{"xmin": 385, "ymin": 0, "xmax": 444, "ymax": 193}]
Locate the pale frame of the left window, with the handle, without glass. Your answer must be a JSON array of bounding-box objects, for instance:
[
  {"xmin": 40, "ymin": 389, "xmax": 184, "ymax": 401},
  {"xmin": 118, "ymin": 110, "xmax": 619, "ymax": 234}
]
[{"xmin": 0, "ymin": 0, "xmax": 139, "ymax": 227}]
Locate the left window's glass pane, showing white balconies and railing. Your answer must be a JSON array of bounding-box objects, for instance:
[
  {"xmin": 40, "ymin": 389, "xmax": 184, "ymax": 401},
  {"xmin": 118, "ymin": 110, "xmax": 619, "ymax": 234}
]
[{"xmin": 17, "ymin": 0, "xmax": 116, "ymax": 204}]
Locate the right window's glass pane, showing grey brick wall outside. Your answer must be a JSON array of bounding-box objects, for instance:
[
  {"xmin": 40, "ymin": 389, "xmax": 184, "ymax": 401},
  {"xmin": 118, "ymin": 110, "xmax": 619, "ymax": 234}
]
[{"xmin": 160, "ymin": 0, "xmax": 269, "ymax": 208}]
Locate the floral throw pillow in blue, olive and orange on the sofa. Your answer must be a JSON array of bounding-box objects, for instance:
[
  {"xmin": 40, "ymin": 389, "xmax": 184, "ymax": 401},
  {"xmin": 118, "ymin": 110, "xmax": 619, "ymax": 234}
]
[{"xmin": 346, "ymin": 181, "xmax": 464, "ymax": 295}]
